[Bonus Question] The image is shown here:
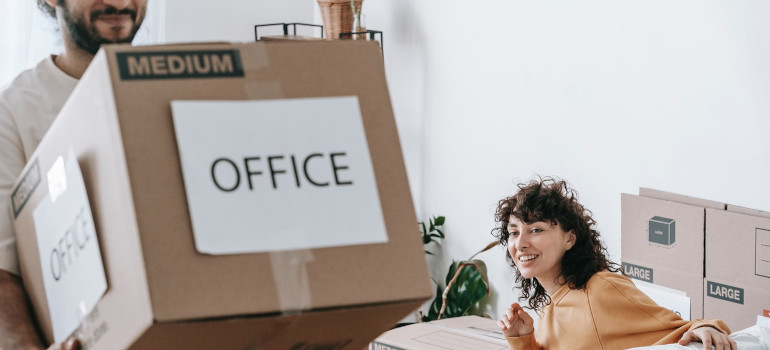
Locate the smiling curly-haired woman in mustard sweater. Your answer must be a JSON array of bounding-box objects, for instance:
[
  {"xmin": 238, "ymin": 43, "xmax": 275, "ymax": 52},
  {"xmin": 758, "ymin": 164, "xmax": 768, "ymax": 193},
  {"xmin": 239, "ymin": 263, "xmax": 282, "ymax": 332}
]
[{"xmin": 493, "ymin": 178, "xmax": 737, "ymax": 350}]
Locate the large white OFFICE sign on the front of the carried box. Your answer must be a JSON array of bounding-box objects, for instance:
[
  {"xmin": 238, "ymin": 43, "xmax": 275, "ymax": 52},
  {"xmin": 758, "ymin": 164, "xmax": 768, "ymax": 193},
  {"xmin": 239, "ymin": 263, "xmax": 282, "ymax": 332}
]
[{"xmin": 171, "ymin": 96, "xmax": 388, "ymax": 255}]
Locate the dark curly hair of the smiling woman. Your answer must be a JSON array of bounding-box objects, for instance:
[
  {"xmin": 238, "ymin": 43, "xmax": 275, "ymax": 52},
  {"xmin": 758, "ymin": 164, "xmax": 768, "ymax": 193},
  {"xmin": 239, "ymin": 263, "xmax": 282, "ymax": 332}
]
[{"xmin": 492, "ymin": 177, "xmax": 619, "ymax": 310}]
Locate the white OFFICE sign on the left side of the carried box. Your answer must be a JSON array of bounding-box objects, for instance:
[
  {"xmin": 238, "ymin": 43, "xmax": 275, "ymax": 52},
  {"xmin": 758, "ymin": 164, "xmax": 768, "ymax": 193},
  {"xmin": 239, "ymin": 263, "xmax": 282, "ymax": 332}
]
[{"xmin": 32, "ymin": 151, "xmax": 107, "ymax": 342}]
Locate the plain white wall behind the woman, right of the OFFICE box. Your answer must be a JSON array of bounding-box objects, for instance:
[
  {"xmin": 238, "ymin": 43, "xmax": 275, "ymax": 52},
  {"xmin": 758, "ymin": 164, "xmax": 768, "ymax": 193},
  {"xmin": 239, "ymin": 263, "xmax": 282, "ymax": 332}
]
[{"xmin": 364, "ymin": 0, "xmax": 770, "ymax": 317}]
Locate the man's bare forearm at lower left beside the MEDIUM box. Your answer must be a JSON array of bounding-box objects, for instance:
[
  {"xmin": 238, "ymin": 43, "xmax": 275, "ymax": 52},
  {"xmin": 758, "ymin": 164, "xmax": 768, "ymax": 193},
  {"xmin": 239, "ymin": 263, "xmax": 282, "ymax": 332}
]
[{"xmin": 0, "ymin": 270, "xmax": 44, "ymax": 350}]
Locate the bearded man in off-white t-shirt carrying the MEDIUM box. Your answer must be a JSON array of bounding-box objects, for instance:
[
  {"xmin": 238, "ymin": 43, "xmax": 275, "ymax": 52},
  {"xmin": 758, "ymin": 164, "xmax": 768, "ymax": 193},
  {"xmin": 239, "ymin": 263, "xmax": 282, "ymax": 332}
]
[{"xmin": 0, "ymin": 0, "xmax": 147, "ymax": 349}]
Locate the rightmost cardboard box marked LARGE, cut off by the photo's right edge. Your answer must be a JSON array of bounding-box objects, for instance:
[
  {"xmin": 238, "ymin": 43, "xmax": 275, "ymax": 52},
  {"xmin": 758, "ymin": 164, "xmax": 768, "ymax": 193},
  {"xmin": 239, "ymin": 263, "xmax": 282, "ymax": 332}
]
[{"xmin": 704, "ymin": 206, "xmax": 770, "ymax": 329}]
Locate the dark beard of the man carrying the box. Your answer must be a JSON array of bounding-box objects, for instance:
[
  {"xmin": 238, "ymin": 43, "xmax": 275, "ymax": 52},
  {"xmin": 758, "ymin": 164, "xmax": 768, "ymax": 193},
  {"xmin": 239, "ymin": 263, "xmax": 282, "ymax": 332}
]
[{"xmin": 59, "ymin": 0, "xmax": 141, "ymax": 55}]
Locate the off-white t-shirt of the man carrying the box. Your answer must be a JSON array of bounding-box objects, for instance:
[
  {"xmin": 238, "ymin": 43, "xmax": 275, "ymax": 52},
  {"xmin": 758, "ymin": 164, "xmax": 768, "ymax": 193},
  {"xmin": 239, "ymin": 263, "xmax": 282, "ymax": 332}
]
[{"xmin": 0, "ymin": 56, "xmax": 78, "ymax": 275}]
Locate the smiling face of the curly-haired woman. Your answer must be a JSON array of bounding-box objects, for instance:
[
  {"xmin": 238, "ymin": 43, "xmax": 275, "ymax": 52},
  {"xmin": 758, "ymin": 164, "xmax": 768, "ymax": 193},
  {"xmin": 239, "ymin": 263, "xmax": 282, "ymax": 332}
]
[{"xmin": 508, "ymin": 215, "xmax": 576, "ymax": 283}]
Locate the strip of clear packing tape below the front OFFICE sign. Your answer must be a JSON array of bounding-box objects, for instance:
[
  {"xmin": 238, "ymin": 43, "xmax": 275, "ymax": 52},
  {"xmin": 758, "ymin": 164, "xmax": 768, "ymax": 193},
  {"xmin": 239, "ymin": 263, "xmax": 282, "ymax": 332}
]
[{"xmin": 270, "ymin": 249, "xmax": 313, "ymax": 314}]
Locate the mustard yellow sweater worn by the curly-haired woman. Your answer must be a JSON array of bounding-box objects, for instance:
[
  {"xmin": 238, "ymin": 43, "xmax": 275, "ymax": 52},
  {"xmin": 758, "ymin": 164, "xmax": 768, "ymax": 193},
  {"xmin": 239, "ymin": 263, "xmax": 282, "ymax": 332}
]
[{"xmin": 507, "ymin": 271, "xmax": 730, "ymax": 350}]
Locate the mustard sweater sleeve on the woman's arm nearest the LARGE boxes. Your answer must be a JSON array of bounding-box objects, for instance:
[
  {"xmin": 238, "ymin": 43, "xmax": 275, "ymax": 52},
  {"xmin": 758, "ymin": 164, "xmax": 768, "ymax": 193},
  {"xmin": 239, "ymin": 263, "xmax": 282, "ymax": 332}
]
[{"xmin": 588, "ymin": 273, "xmax": 730, "ymax": 349}]
